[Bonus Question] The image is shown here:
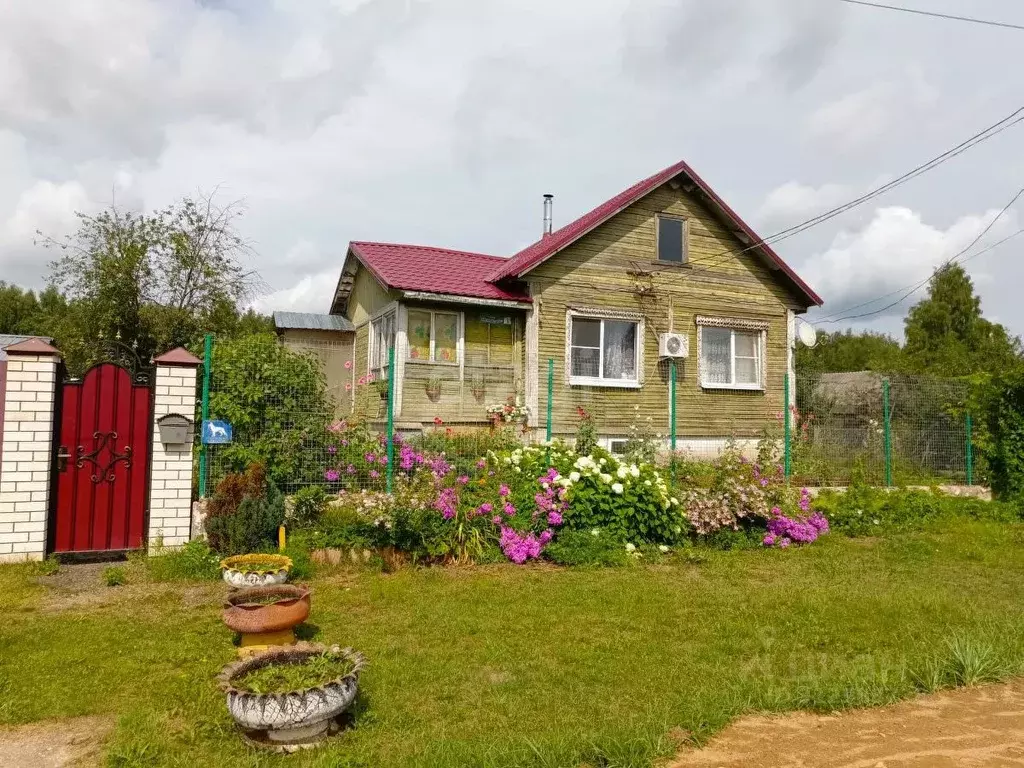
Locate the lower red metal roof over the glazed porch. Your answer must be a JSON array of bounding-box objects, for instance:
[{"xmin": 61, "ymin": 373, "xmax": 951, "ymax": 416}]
[{"xmin": 349, "ymin": 242, "xmax": 530, "ymax": 302}]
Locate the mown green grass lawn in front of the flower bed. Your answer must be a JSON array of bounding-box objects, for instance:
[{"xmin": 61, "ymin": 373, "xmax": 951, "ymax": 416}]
[{"xmin": 0, "ymin": 521, "xmax": 1024, "ymax": 768}]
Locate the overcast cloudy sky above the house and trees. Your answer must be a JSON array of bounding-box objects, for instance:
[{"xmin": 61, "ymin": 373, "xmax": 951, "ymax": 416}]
[{"xmin": 0, "ymin": 0, "xmax": 1024, "ymax": 333}]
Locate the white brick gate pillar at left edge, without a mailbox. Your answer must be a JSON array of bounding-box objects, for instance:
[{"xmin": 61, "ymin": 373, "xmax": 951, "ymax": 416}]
[{"xmin": 0, "ymin": 339, "xmax": 60, "ymax": 562}]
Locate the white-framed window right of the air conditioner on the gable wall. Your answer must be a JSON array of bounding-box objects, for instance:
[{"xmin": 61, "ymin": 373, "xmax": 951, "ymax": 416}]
[{"xmin": 697, "ymin": 317, "xmax": 767, "ymax": 389}]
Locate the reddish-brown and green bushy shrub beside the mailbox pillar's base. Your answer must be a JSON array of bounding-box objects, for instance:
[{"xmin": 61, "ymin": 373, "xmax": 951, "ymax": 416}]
[{"xmin": 205, "ymin": 464, "xmax": 285, "ymax": 555}]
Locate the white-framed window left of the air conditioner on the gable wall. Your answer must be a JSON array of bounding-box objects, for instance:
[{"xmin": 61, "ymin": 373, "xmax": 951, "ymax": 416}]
[{"xmin": 567, "ymin": 313, "xmax": 643, "ymax": 387}]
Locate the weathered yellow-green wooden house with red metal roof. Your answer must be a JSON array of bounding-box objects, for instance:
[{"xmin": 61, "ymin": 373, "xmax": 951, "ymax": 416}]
[{"xmin": 286, "ymin": 163, "xmax": 821, "ymax": 450}]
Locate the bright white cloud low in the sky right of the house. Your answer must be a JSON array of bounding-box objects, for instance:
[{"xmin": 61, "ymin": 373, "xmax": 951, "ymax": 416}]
[{"xmin": 803, "ymin": 207, "xmax": 1018, "ymax": 317}]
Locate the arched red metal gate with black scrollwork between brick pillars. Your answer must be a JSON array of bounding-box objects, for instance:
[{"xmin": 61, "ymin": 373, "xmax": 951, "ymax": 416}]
[{"xmin": 50, "ymin": 362, "xmax": 153, "ymax": 552}]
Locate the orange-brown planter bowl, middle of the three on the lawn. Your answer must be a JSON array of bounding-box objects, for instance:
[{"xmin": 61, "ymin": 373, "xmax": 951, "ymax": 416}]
[{"xmin": 221, "ymin": 584, "xmax": 310, "ymax": 656}]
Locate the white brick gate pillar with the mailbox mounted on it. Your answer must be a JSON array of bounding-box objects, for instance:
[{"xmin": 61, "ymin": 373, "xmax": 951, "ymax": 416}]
[{"xmin": 147, "ymin": 347, "xmax": 202, "ymax": 548}]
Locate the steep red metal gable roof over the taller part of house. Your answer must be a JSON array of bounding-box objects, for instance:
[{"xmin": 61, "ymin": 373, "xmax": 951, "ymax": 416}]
[{"xmin": 488, "ymin": 161, "xmax": 822, "ymax": 306}]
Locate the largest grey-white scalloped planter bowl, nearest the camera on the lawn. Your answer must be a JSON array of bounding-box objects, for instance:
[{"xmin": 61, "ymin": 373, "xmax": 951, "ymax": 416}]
[{"xmin": 217, "ymin": 643, "xmax": 366, "ymax": 742}]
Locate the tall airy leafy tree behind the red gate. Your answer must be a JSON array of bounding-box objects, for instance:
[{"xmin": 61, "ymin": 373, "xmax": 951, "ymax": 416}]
[{"xmin": 42, "ymin": 197, "xmax": 259, "ymax": 370}]
